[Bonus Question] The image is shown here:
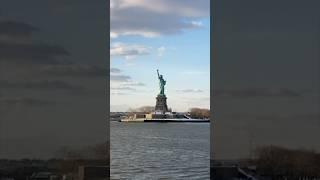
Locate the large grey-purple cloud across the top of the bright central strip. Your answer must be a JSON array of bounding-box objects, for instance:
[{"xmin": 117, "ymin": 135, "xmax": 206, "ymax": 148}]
[{"xmin": 110, "ymin": 0, "xmax": 210, "ymax": 38}]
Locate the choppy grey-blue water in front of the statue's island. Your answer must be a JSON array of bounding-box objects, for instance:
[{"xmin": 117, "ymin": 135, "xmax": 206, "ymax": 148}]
[{"xmin": 111, "ymin": 122, "xmax": 210, "ymax": 180}]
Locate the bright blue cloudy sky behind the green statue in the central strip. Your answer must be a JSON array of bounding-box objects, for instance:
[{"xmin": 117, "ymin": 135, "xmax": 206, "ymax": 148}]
[{"xmin": 110, "ymin": 0, "xmax": 210, "ymax": 111}]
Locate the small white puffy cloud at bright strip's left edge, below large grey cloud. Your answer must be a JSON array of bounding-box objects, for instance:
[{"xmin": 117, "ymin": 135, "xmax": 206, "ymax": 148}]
[{"xmin": 110, "ymin": 43, "xmax": 150, "ymax": 59}]
